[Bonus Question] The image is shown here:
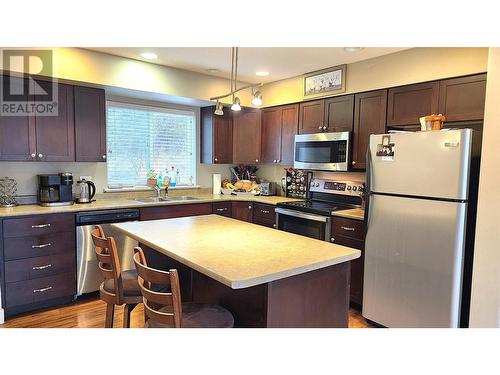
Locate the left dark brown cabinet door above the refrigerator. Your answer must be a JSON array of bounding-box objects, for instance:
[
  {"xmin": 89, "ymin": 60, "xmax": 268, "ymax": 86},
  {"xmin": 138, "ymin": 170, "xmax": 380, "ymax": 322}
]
[{"xmin": 387, "ymin": 82, "xmax": 439, "ymax": 126}]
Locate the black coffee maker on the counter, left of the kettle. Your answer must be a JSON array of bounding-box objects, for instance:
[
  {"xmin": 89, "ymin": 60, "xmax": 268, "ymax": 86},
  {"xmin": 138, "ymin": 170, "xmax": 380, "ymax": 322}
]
[{"xmin": 37, "ymin": 172, "xmax": 74, "ymax": 206}]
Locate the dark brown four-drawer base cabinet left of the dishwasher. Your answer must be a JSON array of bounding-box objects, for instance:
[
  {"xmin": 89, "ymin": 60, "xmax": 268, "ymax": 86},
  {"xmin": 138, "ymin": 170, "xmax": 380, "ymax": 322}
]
[{"xmin": 2, "ymin": 214, "xmax": 76, "ymax": 315}]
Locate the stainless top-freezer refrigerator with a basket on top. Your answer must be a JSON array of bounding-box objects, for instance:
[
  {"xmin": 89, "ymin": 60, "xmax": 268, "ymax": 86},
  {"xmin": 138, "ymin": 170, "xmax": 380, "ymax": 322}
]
[{"xmin": 362, "ymin": 129, "xmax": 472, "ymax": 327}]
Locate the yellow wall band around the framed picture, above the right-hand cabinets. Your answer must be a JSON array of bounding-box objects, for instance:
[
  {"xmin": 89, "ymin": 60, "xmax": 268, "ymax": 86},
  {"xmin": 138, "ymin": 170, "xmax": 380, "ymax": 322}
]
[{"xmin": 262, "ymin": 48, "xmax": 488, "ymax": 106}]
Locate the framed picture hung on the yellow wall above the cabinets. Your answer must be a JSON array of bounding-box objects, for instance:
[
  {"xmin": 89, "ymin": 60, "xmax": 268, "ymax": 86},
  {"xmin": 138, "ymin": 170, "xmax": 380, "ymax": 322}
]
[{"xmin": 304, "ymin": 65, "xmax": 346, "ymax": 96}]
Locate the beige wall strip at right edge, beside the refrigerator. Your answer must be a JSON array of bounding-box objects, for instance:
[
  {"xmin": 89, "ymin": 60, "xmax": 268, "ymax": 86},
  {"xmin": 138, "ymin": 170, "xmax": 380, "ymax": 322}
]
[{"xmin": 470, "ymin": 48, "xmax": 500, "ymax": 327}]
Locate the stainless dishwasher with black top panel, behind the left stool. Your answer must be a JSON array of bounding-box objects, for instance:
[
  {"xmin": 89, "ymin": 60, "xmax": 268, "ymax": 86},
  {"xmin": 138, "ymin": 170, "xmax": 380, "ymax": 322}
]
[{"xmin": 76, "ymin": 209, "xmax": 139, "ymax": 296}]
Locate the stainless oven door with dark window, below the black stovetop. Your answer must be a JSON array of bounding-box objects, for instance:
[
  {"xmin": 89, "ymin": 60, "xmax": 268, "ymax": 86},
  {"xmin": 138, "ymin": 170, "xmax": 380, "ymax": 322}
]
[{"xmin": 275, "ymin": 207, "xmax": 331, "ymax": 241}]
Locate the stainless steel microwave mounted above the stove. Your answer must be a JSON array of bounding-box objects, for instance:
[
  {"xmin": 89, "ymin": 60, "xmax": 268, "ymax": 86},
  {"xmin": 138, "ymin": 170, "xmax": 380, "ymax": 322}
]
[{"xmin": 293, "ymin": 132, "xmax": 351, "ymax": 171}]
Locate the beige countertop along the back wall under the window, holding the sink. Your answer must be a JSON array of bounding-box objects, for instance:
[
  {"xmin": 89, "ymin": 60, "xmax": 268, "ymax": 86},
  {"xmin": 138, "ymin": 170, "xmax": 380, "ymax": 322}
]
[{"xmin": 0, "ymin": 192, "xmax": 298, "ymax": 218}]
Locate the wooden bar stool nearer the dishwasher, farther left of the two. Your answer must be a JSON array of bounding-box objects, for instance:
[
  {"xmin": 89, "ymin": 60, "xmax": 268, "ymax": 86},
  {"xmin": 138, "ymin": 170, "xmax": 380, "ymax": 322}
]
[{"xmin": 91, "ymin": 225, "xmax": 142, "ymax": 328}]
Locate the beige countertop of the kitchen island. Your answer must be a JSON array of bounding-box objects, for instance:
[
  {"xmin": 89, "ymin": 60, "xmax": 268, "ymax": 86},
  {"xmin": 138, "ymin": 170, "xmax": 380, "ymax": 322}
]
[{"xmin": 112, "ymin": 215, "xmax": 361, "ymax": 289}]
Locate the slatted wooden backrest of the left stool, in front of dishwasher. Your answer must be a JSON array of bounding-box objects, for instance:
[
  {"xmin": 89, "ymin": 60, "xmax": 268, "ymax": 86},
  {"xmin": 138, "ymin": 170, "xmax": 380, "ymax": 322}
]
[{"xmin": 90, "ymin": 225, "xmax": 123, "ymax": 304}]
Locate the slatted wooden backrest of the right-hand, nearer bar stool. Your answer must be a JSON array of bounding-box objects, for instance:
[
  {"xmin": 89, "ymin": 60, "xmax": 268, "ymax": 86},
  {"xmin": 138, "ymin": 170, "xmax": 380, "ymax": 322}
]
[{"xmin": 134, "ymin": 247, "xmax": 182, "ymax": 328}]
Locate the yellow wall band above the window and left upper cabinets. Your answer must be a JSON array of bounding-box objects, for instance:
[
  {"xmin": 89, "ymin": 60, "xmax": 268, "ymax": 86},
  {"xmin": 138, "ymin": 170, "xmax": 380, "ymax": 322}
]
[{"xmin": 0, "ymin": 48, "xmax": 251, "ymax": 105}]
